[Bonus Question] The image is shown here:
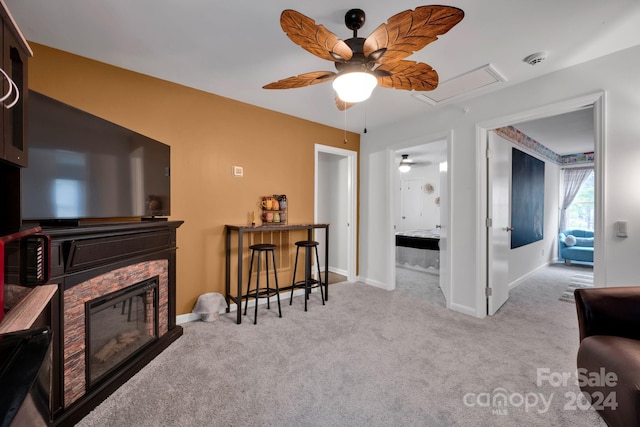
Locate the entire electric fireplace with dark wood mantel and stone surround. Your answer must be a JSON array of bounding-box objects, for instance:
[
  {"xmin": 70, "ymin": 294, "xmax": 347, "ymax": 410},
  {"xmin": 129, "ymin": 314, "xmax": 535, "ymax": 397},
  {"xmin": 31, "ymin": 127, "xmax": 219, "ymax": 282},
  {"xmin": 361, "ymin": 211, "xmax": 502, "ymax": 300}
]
[{"xmin": 27, "ymin": 221, "xmax": 182, "ymax": 427}]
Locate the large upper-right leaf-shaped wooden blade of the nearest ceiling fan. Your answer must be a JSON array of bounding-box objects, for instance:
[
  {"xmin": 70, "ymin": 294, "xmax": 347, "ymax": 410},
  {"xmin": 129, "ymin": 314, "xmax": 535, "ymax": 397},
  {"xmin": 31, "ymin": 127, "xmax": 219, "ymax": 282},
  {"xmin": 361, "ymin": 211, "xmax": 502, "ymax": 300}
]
[{"xmin": 363, "ymin": 6, "xmax": 464, "ymax": 64}]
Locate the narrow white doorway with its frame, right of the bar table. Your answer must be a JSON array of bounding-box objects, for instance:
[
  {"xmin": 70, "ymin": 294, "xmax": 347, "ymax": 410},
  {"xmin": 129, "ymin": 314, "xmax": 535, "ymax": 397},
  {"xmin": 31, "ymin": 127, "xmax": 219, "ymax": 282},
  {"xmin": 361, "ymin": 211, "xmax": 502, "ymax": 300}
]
[{"xmin": 314, "ymin": 144, "xmax": 358, "ymax": 283}]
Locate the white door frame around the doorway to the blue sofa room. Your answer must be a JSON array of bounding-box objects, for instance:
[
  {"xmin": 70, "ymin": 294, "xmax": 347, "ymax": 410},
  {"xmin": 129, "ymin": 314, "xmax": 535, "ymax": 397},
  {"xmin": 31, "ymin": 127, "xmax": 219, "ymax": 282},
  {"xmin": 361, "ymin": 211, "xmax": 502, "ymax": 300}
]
[{"xmin": 476, "ymin": 91, "xmax": 607, "ymax": 317}]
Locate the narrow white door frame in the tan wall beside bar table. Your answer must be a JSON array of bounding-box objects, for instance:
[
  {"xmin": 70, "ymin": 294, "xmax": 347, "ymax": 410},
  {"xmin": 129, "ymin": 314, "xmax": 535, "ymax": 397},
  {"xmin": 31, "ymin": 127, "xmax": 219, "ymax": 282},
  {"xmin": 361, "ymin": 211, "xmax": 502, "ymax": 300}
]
[{"xmin": 313, "ymin": 144, "xmax": 358, "ymax": 282}]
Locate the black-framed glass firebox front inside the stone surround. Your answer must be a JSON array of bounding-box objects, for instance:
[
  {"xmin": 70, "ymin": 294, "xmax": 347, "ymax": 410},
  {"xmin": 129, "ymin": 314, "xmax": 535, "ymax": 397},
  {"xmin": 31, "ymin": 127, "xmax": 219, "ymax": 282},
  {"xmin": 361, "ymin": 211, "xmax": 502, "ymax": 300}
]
[{"xmin": 85, "ymin": 277, "xmax": 158, "ymax": 387}]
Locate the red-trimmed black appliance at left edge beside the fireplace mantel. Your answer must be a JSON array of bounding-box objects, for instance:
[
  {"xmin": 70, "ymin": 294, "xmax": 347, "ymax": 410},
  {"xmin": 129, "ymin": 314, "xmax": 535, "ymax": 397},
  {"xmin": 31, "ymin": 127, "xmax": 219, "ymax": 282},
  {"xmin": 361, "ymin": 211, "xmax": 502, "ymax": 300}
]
[{"xmin": 0, "ymin": 227, "xmax": 51, "ymax": 322}]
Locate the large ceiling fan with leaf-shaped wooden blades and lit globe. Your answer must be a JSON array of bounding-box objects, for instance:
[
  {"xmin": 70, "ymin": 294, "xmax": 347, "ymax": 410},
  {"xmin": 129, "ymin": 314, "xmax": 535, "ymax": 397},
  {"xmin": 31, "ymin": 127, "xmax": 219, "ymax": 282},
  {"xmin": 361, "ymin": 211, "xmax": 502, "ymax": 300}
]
[{"xmin": 263, "ymin": 6, "xmax": 464, "ymax": 110}]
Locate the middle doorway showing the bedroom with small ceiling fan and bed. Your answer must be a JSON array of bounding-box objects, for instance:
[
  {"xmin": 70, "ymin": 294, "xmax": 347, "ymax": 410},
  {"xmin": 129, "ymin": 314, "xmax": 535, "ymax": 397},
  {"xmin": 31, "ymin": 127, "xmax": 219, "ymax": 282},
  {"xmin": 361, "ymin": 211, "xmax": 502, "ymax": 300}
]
[{"xmin": 389, "ymin": 137, "xmax": 450, "ymax": 307}]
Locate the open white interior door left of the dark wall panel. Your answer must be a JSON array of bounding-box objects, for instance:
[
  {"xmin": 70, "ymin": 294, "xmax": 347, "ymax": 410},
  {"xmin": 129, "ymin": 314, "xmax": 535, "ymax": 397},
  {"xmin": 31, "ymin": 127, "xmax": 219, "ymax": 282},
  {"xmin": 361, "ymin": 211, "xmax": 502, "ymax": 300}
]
[{"xmin": 487, "ymin": 132, "xmax": 511, "ymax": 315}]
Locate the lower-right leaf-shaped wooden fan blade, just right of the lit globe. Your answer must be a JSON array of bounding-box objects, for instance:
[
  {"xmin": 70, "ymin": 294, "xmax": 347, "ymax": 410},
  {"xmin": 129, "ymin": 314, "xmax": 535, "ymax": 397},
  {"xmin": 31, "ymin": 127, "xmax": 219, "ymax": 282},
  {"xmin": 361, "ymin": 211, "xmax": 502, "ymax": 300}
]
[{"xmin": 374, "ymin": 61, "xmax": 438, "ymax": 91}]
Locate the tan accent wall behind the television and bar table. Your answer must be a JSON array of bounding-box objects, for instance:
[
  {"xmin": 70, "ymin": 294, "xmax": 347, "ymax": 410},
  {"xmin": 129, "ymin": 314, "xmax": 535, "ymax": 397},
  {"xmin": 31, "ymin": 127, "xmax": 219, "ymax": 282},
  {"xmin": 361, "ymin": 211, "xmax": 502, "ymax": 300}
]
[{"xmin": 29, "ymin": 42, "xmax": 360, "ymax": 314}]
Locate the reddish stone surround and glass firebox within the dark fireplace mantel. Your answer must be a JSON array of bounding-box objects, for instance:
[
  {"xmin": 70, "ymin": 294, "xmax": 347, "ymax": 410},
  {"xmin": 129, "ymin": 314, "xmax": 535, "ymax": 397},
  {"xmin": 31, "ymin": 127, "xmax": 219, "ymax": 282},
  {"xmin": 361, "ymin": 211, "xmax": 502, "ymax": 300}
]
[{"xmin": 64, "ymin": 260, "xmax": 168, "ymax": 407}]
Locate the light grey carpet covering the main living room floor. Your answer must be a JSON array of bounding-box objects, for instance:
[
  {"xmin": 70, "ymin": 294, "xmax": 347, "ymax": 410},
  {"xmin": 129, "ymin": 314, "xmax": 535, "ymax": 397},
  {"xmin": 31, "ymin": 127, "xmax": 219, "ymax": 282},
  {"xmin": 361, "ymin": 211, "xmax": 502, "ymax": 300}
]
[{"xmin": 78, "ymin": 266, "xmax": 605, "ymax": 427}]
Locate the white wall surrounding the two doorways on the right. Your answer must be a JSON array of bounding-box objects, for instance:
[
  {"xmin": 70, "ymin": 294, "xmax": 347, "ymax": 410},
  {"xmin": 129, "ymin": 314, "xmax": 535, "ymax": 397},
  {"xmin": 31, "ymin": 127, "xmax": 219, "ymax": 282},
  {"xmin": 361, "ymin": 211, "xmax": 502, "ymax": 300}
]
[{"xmin": 359, "ymin": 46, "xmax": 640, "ymax": 316}]
